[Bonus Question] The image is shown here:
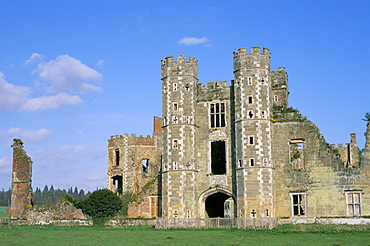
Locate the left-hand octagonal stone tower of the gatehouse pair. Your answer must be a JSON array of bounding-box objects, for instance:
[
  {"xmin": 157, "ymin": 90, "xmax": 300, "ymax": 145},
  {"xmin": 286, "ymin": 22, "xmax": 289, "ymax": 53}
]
[{"xmin": 162, "ymin": 55, "xmax": 198, "ymax": 218}]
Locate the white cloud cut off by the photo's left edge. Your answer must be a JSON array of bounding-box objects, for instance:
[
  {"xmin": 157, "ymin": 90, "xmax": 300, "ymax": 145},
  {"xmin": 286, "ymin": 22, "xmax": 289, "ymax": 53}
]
[{"xmin": 0, "ymin": 72, "xmax": 31, "ymax": 112}]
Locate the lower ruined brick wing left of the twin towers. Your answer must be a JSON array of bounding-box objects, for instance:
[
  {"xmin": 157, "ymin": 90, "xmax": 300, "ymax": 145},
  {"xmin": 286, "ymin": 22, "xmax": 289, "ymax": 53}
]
[{"xmin": 107, "ymin": 117, "xmax": 162, "ymax": 218}]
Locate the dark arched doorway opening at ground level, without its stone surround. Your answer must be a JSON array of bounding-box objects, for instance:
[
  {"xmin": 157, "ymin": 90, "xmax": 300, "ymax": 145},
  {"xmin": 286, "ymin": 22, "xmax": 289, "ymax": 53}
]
[{"xmin": 205, "ymin": 192, "xmax": 232, "ymax": 218}]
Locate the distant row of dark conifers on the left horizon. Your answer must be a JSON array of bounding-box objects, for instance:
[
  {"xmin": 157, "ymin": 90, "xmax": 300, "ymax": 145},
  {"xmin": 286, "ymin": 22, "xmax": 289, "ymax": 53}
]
[{"xmin": 0, "ymin": 185, "xmax": 91, "ymax": 206}]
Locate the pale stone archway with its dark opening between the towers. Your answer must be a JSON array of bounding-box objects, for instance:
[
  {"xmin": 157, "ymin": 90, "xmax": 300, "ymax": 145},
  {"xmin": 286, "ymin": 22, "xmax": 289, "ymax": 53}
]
[{"xmin": 199, "ymin": 187, "xmax": 235, "ymax": 218}]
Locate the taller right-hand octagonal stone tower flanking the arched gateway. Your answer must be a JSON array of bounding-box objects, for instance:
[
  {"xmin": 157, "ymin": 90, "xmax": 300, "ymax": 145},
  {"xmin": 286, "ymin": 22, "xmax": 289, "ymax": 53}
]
[{"xmin": 233, "ymin": 47, "xmax": 273, "ymax": 217}]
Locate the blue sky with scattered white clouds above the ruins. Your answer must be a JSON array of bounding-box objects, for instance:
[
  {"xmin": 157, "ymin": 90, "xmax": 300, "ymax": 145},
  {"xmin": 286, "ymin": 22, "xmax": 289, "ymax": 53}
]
[{"xmin": 0, "ymin": 0, "xmax": 370, "ymax": 190}]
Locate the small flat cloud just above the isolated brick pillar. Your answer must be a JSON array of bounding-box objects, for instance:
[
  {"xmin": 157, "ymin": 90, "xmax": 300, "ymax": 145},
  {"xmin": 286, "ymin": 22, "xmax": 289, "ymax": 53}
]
[{"xmin": 3, "ymin": 127, "xmax": 51, "ymax": 142}]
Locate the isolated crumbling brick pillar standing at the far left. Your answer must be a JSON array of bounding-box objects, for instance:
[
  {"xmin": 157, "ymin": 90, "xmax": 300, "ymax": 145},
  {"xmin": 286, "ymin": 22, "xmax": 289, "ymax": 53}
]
[{"xmin": 11, "ymin": 139, "xmax": 33, "ymax": 219}]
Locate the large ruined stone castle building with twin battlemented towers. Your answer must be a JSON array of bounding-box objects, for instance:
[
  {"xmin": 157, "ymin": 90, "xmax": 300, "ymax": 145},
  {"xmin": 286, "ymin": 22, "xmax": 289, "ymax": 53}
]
[{"xmin": 107, "ymin": 47, "xmax": 370, "ymax": 218}]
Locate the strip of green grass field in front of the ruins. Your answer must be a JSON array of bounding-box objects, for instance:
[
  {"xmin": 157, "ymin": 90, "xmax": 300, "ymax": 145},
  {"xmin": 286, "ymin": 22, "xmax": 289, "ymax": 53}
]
[{"xmin": 0, "ymin": 225, "xmax": 370, "ymax": 245}]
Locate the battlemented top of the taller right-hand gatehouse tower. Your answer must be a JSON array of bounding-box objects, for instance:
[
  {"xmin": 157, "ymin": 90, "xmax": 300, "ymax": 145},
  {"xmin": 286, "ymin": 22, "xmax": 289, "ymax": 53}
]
[{"xmin": 233, "ymin": 47, "xmax": 271, "ymax": 72}]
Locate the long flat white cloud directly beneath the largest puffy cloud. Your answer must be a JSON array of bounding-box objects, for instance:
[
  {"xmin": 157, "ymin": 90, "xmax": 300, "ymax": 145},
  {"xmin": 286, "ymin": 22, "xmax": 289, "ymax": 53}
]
[{"xmin": 21, "ymin": 93, "xmax": 83, "ymax": 112}]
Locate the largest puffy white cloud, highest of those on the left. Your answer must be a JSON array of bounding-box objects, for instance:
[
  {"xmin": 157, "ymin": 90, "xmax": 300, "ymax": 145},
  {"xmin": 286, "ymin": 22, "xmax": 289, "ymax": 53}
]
[{"xmin": 34, "ymin": 55, "xmax": 102, "ymax": 92}]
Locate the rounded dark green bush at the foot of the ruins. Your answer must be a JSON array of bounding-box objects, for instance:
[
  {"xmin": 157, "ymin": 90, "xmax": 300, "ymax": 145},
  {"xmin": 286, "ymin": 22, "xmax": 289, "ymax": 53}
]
[{"xmin": 76, "ymin": 189, "xmax": 122, "ymax": 225}]
